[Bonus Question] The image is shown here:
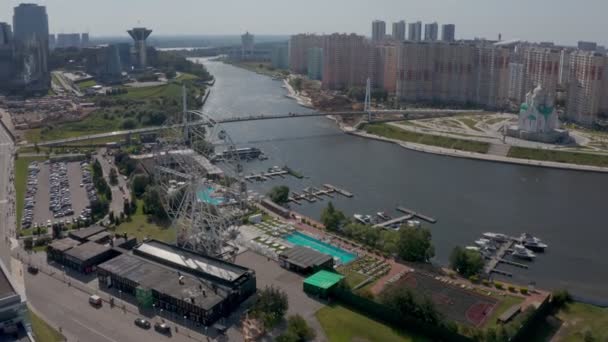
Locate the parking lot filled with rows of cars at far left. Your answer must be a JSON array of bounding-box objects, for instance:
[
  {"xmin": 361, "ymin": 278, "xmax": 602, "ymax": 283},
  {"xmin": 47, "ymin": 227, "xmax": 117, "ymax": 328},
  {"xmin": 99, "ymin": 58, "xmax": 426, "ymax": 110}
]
[{"xmin": 22, "ymin": 161, "xmax": 96, "ymax": 228}]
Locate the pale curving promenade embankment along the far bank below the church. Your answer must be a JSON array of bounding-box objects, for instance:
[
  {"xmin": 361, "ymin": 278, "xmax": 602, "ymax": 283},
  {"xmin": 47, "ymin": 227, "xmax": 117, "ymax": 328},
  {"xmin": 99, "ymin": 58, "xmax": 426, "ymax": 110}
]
[{"xmin": 350, "ymin": 125, "xmax": 608, "ymax": 173}]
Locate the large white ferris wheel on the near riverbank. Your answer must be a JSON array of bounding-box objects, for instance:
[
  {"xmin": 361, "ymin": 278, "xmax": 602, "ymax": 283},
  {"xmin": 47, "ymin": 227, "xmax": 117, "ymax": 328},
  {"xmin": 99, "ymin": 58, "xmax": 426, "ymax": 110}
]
[{"xmin": 154, "ymin": 90, "xmax": 247, "ymax": 257}]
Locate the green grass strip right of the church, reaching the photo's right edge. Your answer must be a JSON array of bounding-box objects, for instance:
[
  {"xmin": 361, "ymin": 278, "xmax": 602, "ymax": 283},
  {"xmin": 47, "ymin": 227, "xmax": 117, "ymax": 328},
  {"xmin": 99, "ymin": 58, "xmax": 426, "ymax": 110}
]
[{"xmin": 508, "ymin": 146, "xmax": 608, "ymax": 167}]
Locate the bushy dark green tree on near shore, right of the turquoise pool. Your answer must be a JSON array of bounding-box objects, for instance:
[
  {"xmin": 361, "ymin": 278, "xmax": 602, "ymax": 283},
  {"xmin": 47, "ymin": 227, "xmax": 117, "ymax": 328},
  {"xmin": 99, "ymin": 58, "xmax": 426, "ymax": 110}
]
[{"xmin": 397, "ymin": 225, "xmax": 435, "ymax": 262}]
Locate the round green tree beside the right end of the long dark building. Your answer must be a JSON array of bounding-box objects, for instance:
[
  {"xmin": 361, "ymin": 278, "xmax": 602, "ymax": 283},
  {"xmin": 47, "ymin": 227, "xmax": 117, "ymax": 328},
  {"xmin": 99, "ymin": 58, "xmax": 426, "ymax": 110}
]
[{"xmin": 252, "ymin": 286, "xmax": 289, "ymax": 330}]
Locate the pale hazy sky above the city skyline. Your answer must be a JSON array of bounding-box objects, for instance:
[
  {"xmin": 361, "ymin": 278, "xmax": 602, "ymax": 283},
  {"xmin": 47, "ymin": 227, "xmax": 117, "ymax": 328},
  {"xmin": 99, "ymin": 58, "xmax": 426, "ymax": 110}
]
[{"xmin": 0, "ymin": 0, "xmax": 608, "ymax": 45}]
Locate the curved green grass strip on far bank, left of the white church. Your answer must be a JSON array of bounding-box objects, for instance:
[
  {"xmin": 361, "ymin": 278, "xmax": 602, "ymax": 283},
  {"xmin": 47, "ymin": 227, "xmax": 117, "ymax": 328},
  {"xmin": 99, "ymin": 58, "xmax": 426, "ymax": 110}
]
[{"xmin": 364, "ymin": 124, "xmax": 490, "ymax": 153}]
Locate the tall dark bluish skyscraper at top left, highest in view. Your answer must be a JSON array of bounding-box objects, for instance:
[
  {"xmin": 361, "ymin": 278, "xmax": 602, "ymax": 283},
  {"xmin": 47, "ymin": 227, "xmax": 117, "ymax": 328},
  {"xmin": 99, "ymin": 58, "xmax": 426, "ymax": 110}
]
[{"xmin": 13, "ymin": 4, "xmax": 51, "ymax": 93}]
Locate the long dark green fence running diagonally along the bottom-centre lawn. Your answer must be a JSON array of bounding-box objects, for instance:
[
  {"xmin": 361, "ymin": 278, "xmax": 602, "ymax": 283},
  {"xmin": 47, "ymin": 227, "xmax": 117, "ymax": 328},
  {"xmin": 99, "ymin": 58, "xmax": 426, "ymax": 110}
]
[{"xmin": 332, "ymin": 288, "xmax": 473, "ymax": 342}]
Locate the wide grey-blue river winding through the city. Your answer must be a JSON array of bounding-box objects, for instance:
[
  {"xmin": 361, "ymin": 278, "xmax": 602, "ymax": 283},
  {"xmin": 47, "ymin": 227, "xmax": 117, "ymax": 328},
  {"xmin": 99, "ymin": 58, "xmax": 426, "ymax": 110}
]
[{"xmin": 200, "ymin": 59, "xmax": 608, "ymax": 301}]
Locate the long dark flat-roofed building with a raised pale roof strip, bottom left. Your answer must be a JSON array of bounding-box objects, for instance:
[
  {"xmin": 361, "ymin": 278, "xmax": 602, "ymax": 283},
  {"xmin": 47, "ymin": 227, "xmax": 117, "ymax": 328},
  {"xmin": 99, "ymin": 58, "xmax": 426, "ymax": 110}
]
[{"xmin": 97, "ymin": 240, "xmax": 256, "ymax": 326}]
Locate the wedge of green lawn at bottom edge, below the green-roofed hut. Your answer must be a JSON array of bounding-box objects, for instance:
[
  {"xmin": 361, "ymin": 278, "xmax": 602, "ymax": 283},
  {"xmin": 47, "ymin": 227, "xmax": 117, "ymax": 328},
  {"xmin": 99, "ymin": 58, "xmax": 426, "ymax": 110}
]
[{"xmin": 315, "ymin": 305, "xmax": 428, "ymax": 342}]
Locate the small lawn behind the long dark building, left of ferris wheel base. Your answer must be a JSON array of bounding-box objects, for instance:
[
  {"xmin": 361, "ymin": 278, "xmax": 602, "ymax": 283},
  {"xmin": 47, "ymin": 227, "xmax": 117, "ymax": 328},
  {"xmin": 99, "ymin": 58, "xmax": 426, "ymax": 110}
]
[{"xmin": 116, "ymin": 200, "xmax": 176, "ymax": 242}]
